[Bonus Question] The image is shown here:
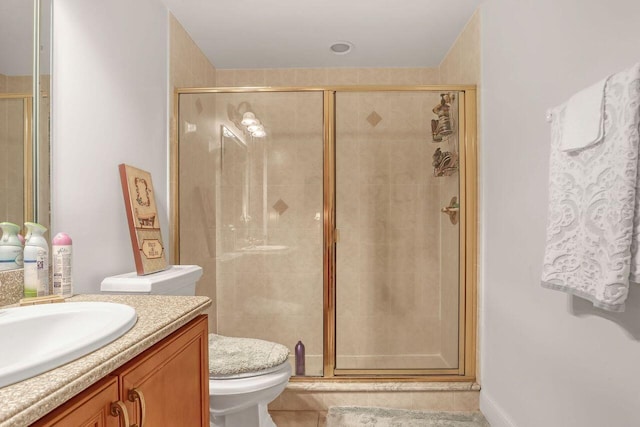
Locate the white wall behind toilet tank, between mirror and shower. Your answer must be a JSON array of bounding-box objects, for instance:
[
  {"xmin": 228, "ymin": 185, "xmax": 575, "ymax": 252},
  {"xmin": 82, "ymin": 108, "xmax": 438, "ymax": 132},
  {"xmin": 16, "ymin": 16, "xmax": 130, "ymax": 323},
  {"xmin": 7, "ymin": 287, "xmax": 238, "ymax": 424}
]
[{"xmin": 52, "ymin": 0, "xmax": 169, "ymax": 293}]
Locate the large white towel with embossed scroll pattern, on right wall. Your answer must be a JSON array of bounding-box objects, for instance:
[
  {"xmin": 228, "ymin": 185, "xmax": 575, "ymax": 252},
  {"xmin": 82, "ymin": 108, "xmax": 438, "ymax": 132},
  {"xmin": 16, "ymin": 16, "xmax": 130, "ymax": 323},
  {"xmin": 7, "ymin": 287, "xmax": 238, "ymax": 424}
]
[{"xmin": 542, "ymin": 63, "xmax": 640, "ymax": 311}]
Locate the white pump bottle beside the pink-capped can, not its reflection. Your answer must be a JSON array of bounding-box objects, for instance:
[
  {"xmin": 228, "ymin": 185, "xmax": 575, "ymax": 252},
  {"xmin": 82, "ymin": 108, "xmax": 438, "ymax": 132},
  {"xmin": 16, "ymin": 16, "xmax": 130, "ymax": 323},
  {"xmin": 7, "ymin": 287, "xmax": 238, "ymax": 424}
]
[{"xmin": 24, "ymin": 222, "xmax": 49, "ymax": 297}]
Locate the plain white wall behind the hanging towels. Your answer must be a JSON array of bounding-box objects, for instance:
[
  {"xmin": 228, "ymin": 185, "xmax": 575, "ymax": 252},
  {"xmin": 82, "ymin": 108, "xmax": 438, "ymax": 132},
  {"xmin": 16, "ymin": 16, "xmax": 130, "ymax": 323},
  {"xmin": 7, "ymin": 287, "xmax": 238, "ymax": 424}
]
[{"xmin": 481, "ymin": 0, "xmax": 640, "ymax": 427}]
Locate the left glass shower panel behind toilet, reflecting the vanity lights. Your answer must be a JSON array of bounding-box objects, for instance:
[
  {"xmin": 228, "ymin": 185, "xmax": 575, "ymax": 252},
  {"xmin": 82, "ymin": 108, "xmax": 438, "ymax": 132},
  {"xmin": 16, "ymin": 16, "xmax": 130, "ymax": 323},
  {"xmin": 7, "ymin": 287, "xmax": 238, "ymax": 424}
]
[{"xmin": 179, "ymin": 91, "xmax": 324, "ymax": 376}]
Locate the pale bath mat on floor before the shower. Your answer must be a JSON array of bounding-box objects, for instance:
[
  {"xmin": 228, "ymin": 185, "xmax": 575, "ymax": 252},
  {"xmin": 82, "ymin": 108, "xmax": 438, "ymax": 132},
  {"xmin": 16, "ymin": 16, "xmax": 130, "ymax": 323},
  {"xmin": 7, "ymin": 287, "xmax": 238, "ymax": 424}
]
[{"xmin": 326, "ymin": 406, "xmax": 490, "ymax": 427}]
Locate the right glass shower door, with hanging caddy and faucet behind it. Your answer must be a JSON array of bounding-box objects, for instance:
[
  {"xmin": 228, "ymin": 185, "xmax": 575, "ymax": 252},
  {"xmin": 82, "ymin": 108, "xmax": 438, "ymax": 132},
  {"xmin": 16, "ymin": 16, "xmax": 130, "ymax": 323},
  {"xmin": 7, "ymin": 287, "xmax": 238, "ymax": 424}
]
[{"xmin": 335, "ymin": 91, "xmax": 460, "ymax": 375}]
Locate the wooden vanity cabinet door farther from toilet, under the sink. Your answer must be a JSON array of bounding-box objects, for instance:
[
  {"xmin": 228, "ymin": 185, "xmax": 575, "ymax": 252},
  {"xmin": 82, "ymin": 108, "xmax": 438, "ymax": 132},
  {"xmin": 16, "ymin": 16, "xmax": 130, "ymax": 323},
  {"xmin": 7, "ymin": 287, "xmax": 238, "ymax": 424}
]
[{"xmin": 32, "ymin": 377, "xmax": 125, "ymax": 427}]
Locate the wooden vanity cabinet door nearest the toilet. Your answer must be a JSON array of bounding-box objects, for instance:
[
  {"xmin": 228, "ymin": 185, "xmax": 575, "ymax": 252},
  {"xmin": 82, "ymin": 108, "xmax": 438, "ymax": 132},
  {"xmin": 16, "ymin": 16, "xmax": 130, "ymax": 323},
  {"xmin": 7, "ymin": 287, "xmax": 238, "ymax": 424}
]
[{"xmin": 116, "ymin": 316, "xmax": 209, "ymax": 427}]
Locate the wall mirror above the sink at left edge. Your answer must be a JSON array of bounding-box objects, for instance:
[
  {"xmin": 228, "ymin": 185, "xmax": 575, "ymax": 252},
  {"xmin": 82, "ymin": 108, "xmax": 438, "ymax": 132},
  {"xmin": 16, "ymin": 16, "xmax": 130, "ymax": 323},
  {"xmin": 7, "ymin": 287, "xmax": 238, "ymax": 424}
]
[{"xmin": 0, "ymin": 0, "xmax": 52, "ymax": 270}]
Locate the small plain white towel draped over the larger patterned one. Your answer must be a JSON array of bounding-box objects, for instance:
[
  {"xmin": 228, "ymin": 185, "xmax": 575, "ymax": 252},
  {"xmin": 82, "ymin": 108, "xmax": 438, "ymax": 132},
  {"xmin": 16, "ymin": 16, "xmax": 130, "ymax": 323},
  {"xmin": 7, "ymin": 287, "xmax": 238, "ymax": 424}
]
[{"xmin": 561, "ymin": 78, "xmax": 608, "ymax": 151}]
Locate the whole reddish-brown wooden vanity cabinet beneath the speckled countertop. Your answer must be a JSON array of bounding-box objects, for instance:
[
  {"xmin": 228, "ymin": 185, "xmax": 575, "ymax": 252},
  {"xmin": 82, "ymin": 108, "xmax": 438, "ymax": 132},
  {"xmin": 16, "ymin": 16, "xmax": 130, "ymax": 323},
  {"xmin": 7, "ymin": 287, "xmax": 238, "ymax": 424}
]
[{"xmin": 33, "ymin": 315, "xmax": 209, "ymax": 427}]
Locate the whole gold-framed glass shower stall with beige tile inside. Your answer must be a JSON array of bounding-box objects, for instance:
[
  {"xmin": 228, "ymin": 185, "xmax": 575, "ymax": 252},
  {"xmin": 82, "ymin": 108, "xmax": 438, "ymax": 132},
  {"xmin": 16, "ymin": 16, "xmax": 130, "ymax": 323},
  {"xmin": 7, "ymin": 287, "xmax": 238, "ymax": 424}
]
[{"xmin": 172, "ymin": 86, "xmax": 476, "ymax": 380}]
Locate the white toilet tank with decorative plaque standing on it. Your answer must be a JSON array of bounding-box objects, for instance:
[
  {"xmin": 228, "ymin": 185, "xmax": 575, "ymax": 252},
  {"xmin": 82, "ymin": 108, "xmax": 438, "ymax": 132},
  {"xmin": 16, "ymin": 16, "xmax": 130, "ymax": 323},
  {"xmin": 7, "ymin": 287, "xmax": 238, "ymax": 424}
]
[{"xmin": 100, "ymin": 265, "xmax": 202, "ymax": 296}]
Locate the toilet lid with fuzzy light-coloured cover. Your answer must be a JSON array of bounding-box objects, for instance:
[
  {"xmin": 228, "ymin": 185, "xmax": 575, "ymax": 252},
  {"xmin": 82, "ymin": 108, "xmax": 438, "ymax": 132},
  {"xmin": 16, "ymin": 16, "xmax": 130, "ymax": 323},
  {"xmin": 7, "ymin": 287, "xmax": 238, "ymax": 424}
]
[{"xmin": 209, "ymin": 334, "xmax": 289, "ymax": 377}]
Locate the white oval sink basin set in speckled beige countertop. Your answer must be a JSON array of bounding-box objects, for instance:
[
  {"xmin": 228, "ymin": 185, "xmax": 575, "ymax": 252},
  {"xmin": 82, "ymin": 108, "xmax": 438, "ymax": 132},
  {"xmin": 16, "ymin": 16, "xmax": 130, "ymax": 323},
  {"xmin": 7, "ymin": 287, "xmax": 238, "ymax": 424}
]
[{"xmin": 0, "ymin": 302, "xmax": 137, "ymax": 387}]
